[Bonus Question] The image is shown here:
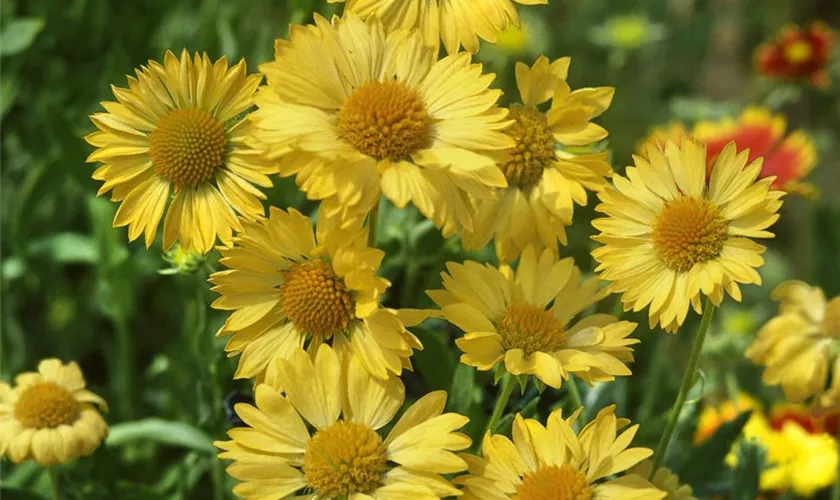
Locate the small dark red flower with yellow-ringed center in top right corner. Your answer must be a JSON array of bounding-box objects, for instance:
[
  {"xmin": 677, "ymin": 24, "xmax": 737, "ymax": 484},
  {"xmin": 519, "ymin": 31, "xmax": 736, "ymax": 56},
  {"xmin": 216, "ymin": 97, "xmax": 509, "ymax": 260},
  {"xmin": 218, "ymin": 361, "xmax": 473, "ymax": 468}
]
[{"xmin": 755, "ymin": 22, "xmax": 837, "ymax": 87}]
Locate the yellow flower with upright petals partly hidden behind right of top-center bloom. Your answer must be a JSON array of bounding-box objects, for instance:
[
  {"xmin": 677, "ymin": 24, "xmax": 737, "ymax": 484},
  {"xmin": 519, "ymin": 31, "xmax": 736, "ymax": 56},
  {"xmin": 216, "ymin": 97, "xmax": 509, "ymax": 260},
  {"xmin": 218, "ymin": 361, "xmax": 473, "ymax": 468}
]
[{"xmin": 462, "ymin": 57, "xmax": 615, "ymax": 262}]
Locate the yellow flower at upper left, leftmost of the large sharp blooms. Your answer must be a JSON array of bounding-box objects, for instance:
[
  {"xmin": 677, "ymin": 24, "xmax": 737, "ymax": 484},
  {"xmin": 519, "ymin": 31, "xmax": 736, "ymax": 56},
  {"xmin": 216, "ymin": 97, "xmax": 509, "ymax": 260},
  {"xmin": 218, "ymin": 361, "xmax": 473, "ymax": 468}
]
[{"xmin": 85, "ymin": 50, "xmax": 276, "ymax": 253}]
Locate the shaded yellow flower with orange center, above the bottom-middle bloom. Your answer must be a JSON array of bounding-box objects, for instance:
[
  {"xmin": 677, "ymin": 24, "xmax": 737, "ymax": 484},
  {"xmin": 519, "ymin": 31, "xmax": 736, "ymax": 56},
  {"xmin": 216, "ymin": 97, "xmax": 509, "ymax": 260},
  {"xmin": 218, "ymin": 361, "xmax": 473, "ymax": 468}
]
[{"xmin": 210, "ymin": 207, "xmax": 422, "ymax": 378}]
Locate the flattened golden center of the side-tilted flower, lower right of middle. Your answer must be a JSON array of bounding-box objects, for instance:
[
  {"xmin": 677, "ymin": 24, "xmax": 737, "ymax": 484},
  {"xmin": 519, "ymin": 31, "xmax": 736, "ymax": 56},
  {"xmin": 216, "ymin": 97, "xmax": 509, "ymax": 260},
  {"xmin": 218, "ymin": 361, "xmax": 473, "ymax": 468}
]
[{"xmin": 496, "ymin": 302, "xmax": 566, "ymax": 356}]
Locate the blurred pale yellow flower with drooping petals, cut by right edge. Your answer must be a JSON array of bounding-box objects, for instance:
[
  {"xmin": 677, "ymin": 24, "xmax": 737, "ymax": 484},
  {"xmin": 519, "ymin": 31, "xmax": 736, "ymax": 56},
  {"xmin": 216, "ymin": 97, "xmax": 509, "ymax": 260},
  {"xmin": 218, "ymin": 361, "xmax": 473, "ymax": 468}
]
[{"xmin": 746, "ymin": 281, "xmax": 840, "ymax": 406}]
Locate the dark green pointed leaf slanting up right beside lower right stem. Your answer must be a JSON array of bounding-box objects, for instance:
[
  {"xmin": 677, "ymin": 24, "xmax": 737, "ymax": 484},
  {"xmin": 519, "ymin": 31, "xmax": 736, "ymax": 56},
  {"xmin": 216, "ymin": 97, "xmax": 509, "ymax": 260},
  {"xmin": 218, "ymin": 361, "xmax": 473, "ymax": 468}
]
[{"xmin": 674, "ymin": 411, "xmax": 752, "ymax": 487}]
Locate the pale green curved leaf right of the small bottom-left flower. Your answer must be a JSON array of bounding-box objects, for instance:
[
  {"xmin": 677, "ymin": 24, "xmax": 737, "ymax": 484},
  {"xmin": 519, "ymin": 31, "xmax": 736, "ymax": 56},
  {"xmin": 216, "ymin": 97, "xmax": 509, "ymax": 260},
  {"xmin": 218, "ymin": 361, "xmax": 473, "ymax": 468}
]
[{"xmin": 105, "ymin": 418, "xmax": 218, "ymax": 453}]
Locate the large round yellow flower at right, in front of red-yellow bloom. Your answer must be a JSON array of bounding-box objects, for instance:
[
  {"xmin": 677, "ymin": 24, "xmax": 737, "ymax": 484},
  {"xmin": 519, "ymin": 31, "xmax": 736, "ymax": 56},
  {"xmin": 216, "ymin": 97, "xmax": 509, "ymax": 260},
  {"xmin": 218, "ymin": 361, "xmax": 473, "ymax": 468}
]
[{"xmin": 592, "ymin": 140, "xmax": 784, "ymax": 332}]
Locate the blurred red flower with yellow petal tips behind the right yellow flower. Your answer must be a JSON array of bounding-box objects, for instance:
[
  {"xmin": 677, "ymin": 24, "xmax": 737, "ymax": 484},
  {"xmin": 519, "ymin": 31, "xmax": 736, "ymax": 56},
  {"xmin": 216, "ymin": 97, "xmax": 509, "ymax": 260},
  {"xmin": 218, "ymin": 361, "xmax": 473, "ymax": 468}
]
[{"xmin": 691, "ymin": 107, "xmax": 817, "ymax": 196}]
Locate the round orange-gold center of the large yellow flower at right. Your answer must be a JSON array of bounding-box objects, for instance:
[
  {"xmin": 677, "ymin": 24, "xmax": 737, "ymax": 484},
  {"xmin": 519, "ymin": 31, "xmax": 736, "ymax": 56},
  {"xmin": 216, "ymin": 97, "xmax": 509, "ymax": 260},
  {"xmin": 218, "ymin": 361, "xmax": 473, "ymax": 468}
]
[{"xmin": 653, "ymin": 196, "xmax": 727, "ymax": 272}]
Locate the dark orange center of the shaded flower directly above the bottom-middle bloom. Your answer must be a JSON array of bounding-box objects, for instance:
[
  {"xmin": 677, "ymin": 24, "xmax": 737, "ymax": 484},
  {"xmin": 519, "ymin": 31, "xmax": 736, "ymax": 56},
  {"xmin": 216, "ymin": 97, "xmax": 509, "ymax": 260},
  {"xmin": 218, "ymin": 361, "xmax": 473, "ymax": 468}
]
[{"xmin": 280, "ymin": 260, "xmax": 356, "ymax": 339}]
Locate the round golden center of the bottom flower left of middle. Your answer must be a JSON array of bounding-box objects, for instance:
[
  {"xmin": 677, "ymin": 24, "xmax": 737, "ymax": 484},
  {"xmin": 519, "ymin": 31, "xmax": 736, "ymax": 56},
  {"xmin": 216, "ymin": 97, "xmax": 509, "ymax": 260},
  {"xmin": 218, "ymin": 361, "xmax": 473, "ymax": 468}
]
[{"xmin": 303, "ymin": 421, "xmax": 387, "ymax": 498}]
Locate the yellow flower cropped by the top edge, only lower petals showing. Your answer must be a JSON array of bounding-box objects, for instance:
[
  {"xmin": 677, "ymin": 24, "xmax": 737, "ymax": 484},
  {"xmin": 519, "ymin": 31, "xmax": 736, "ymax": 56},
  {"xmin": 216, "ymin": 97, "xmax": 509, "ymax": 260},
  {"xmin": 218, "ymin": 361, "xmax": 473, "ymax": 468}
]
[{"xmin": 328, "ymin": 0, "xmax": 548, "ymax": 54}]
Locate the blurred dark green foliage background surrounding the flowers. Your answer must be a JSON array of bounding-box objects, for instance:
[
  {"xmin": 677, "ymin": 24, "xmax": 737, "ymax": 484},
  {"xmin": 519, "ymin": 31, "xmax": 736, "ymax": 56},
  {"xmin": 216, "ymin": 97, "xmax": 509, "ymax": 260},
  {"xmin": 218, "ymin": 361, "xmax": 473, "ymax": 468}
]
[{"xmin": 0, "ymin": 0, "xmax": 840, "ymax": 500}]
